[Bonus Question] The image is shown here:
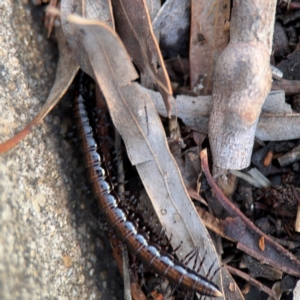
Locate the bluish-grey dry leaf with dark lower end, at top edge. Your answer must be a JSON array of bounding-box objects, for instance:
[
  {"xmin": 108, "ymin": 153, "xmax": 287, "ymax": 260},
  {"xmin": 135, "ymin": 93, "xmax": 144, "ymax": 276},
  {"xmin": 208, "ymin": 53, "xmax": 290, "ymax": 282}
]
[{"xmin": 153, "ymin": 0, "xmax": 191, "ymax": 57}]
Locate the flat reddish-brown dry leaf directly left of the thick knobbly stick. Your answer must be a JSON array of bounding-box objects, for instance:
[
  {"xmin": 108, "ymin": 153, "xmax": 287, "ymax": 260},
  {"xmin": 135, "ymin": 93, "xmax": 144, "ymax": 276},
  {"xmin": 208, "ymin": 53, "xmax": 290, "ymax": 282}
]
[{"xmin": 190, "ymin": 0, "xmax": 230, "ymax": 95}]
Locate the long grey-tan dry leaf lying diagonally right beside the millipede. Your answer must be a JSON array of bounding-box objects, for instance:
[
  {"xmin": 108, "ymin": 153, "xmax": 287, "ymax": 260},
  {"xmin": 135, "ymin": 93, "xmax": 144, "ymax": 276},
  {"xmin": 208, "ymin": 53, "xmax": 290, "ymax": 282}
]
[{"xmin": 69, "ymin": 16, "xmax": 222, "ymax": 296}]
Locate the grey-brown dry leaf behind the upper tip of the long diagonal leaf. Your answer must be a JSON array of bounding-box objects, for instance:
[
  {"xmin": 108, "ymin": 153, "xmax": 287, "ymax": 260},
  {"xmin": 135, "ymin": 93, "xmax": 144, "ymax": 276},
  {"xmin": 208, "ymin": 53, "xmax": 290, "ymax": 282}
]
[{"xmin": 61, "ymin": 0, "xmax": 114, "ymax": 77}]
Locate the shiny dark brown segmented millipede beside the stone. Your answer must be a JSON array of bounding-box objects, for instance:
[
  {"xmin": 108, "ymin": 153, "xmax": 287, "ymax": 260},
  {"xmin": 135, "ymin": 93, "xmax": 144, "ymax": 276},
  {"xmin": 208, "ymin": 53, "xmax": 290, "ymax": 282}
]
[{"xmin": 73, "ymin": 79, "xmax": 222, "ymax": 297}]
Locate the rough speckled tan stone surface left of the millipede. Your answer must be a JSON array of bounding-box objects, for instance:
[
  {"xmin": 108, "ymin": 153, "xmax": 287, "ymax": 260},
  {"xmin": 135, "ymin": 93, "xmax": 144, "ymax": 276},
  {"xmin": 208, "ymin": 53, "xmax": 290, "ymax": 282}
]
[{"xmin": 0, "ymin": 0, "xmax": 123, "ymax": 300}]
